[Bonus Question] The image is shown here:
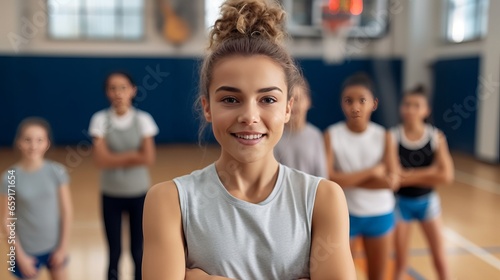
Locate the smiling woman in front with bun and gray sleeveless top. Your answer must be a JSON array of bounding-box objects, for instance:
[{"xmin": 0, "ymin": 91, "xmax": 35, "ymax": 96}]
[{"xmin": 143, "ymin": 0, "xmax": 355, "ymax": 280}]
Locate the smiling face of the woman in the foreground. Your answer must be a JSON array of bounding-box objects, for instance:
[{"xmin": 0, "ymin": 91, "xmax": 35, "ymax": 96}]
[{"xmin": 202, "ymin": 55, "xmax": 293, "ymax": 163}]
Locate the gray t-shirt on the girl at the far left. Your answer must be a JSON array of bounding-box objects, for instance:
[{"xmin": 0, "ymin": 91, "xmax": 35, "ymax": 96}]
[{"xmin": 0, "ymin": 160, "xmax": 69, "ymax": 255}]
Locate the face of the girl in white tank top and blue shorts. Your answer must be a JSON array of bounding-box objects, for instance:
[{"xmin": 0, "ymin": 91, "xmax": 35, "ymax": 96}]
[{"xmin": 342, "ymin": 85, "xmax": 378, "ymax": 125}]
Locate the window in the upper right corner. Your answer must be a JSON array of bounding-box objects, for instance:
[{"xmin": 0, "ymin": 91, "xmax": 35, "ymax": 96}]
[{"xmin": 446, "ymin": 0, "xmax": 488, "ymax": 43}]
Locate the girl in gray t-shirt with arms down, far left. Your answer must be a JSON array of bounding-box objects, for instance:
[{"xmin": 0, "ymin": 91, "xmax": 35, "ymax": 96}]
[{"xmin": 0, "ymin": 118, "xmax": 72, "ymax": 280}]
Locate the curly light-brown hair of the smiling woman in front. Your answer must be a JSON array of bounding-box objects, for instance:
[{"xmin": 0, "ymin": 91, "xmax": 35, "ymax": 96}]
[{"xmin": 197, "ymin": 0, "xmax": 301, "ymax": 138}]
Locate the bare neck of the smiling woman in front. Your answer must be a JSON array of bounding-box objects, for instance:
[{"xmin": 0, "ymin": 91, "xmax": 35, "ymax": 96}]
[{"xmin": 215, "ymin": 153, "xmax": 279, "ymax": 203}]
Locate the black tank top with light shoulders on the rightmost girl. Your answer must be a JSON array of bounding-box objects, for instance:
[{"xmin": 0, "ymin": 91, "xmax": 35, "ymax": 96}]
[{"xmin": 392, "ymin": 124, "xmax": 438, "ymax": 197}]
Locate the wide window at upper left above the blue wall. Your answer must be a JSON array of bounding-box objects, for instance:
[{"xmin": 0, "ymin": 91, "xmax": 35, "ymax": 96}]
[{"xmin": 47, "ymin": 0, "xmax": 144, "ymax": 40}]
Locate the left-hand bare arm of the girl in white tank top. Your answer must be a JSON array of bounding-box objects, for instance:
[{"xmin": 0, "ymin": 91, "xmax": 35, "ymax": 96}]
[{"xmin": 324, "ymin": 132, "xmax": 380, "ymax": 188}]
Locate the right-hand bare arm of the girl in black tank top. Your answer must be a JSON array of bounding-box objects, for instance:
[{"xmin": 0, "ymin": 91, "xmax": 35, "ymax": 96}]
[{"xmin": 401, "ymin": 133, "xmax": 455, "ymax": 187}]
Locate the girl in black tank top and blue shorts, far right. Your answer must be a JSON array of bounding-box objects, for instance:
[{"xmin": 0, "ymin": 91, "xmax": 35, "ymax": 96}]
[{"xmin": 392, "ymin": 86, "xmax": 454, "ymax": 280}]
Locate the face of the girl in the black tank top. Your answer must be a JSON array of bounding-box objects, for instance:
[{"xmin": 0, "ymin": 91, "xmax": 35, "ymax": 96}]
[{"xmin": 399, "ymin": 94, "xmax": 430, "ymax": 124}]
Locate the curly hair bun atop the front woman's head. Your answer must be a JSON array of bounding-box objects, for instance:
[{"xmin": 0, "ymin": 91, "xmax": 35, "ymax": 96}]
[{"xmin": 209, "ymin": 0, "xmax": 285, "ymax": 49}]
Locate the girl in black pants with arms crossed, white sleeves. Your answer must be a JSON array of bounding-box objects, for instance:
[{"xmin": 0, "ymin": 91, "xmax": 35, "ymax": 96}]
[{"xmin": 89, "ymin": 72, "xmax": 158, "ymax": 280}]
